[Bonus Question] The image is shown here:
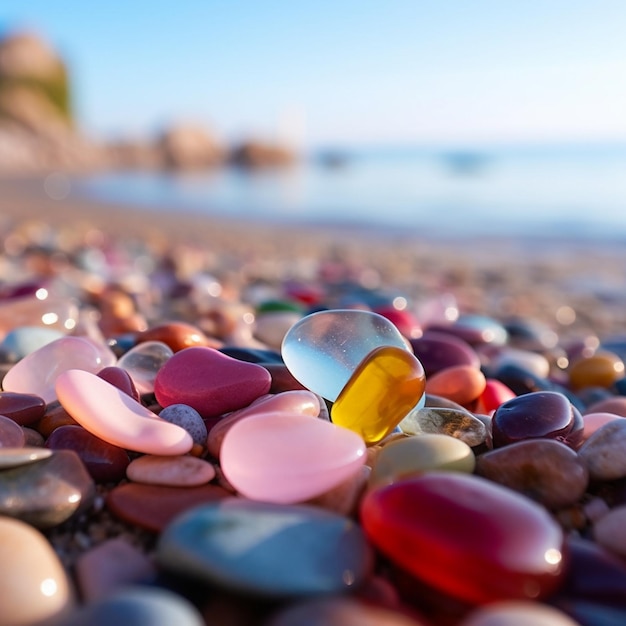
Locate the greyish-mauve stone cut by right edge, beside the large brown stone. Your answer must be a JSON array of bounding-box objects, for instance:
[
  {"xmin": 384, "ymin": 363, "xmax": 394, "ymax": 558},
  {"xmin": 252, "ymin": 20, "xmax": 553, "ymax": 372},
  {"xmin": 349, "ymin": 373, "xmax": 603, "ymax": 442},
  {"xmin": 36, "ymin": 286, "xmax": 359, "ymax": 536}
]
[{"xmin": 578, "ymin": 418, "xmax": 626, "ymax": 481}]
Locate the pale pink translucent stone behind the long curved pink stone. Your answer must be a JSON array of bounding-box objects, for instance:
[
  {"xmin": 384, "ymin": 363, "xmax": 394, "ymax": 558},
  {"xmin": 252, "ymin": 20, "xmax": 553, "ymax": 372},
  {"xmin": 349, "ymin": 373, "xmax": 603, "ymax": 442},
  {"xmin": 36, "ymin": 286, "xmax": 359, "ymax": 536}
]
[{"xmin": 2, "ymin": 337, "xmax": 110, "ymax": 403}]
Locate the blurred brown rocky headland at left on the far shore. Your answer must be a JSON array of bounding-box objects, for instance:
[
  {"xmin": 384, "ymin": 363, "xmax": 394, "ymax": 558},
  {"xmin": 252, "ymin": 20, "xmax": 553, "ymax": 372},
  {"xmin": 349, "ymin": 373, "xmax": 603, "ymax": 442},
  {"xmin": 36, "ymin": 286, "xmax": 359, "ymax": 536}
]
[{"xmin": 0, "ymin": 32, "xmax": 298, "ymax": 174}]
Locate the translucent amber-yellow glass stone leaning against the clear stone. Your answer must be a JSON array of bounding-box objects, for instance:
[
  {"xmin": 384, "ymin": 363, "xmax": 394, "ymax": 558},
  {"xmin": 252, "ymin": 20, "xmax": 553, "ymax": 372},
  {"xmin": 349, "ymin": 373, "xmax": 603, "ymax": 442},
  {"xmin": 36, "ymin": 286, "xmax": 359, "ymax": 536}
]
[{"xmin": 330, "ymin": 346, "xmax": 426, "ymax": 444}]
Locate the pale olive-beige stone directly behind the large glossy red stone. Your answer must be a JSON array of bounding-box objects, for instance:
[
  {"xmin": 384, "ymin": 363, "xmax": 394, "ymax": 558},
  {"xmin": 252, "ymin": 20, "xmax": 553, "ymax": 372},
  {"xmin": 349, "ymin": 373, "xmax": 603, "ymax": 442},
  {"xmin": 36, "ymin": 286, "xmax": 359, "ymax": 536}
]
[{"xmin": 369, "ymin": 435, "xmax": 476, "ymax": 488}]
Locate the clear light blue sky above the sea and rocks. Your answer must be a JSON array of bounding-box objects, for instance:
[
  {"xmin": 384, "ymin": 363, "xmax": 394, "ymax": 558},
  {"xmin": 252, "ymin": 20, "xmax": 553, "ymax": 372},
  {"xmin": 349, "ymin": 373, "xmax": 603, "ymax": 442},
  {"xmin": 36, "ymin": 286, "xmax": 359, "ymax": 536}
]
[{"xmin": 0, "ymin": 0, "xmax": 626, "ymax": 146}]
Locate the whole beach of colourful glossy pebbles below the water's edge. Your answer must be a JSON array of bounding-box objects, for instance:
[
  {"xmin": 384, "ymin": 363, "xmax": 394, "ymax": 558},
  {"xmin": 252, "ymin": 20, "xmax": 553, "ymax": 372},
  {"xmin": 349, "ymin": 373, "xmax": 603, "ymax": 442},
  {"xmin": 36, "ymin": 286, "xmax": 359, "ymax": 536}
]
[{"xmin": 0, "ymin": 172, "xmax": 626, "ymax": 626}]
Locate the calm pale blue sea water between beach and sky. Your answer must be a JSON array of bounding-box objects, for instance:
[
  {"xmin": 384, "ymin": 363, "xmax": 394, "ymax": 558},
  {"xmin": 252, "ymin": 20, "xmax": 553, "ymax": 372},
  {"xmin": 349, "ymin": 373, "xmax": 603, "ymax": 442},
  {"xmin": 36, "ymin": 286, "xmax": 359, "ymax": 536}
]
[{"xmin": 74, "ymin": 145, "xmax": 626, "ymax": 237}]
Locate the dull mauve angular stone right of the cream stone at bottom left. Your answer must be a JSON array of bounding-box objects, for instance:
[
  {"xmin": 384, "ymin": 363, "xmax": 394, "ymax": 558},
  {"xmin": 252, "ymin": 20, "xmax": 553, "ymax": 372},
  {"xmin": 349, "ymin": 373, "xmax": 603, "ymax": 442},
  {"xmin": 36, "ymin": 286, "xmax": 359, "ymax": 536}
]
[{"xmin": 74, "ymin": 537, "xmax": 157, "ymax": 603}]
